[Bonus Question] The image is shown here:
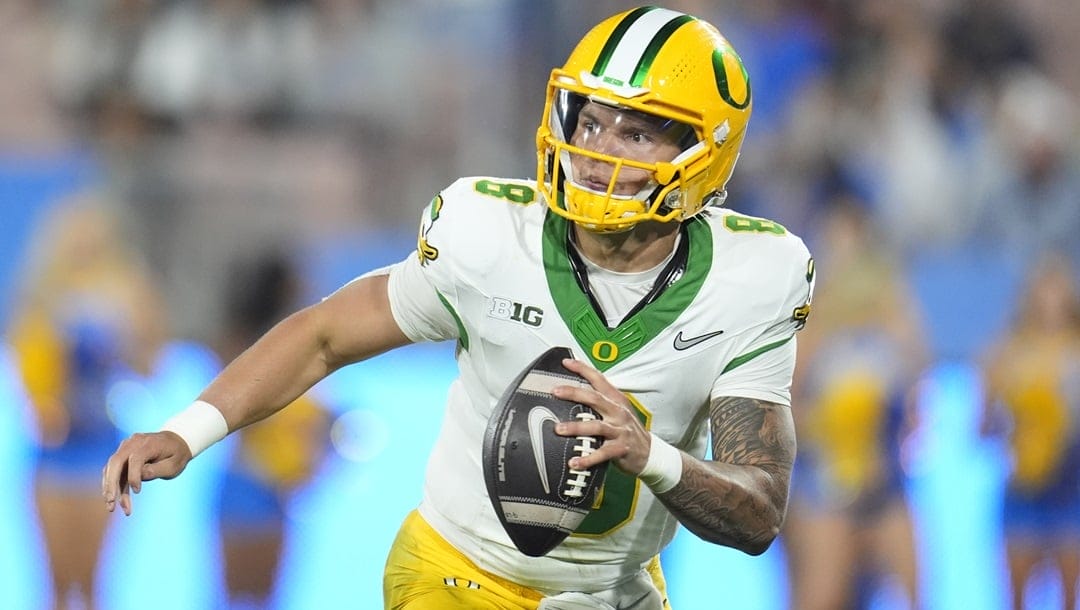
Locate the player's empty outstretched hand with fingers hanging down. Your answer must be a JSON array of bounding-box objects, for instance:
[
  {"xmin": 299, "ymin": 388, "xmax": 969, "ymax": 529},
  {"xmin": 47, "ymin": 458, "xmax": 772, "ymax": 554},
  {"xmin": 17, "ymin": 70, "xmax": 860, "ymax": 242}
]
[{"xmin": 102, "ymin": 432, "xmax": 191, "ymax": 515}]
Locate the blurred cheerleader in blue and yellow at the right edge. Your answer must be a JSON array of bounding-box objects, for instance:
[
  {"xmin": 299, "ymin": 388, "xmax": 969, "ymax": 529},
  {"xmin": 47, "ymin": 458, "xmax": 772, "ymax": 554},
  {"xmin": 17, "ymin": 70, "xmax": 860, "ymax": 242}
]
[{"xmin": 984, "ymin": 250, "xmax": 1080, "ymax": 610}]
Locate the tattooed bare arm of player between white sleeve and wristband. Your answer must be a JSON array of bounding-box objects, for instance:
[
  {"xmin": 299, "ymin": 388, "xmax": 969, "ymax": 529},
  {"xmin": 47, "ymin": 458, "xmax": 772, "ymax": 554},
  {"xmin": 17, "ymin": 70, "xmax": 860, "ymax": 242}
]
[{"xmin": 660, "ymin": 397, "xmax": 795, "ymax": 553}]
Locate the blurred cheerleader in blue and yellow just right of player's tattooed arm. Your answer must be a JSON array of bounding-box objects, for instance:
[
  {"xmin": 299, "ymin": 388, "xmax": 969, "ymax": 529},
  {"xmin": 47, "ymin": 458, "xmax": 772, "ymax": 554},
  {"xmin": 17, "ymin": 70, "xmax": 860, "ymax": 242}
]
[{"xmin": 784, "ymin": 192, "xmax": 926, "ymax": 610}]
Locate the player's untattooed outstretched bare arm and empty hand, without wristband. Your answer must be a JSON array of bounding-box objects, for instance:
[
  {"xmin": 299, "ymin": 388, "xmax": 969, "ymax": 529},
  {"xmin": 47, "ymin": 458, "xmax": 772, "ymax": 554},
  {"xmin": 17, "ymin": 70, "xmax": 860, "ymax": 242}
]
[{"xmin": 102, "ymin": 274, "xmax": 409, "ymax": 515}]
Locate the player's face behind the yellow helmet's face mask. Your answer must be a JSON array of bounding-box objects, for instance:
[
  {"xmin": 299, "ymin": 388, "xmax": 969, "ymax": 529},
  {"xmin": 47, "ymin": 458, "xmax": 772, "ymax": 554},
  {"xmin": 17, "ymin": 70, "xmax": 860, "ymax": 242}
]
[{"xmin": 570, "ymin": 101, "xmax": 680, "ymax": 195}]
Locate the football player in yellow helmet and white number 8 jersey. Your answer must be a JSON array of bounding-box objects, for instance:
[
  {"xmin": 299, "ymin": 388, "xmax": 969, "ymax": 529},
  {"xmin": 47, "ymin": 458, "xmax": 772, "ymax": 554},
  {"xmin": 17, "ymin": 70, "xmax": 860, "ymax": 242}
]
[{"xmin": 103, "ymin": 6, "xmax": 813, "ymax": 610}]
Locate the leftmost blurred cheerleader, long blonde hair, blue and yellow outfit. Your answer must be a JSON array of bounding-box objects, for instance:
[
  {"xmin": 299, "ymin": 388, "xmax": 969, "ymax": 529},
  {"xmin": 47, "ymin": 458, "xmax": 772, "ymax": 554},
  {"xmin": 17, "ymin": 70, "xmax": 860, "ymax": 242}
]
[{"xmin": 10, "ymin": 198, "xmax": 165, "ymax": 608}]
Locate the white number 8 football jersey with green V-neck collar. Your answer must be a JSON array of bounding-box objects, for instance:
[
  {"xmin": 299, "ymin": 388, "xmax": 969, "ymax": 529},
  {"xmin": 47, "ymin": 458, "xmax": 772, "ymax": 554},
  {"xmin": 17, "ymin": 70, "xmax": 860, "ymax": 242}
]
[{"xmin": 389, "ymin": 178, "xmax": 813, "ymax": 593}]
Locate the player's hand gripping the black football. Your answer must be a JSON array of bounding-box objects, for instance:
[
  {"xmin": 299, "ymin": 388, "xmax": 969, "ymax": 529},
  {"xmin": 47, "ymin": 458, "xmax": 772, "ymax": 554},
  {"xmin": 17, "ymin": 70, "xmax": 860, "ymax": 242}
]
[{"xmin": 552, "ymin": 358, "xmax": 652, "ymax": 476}]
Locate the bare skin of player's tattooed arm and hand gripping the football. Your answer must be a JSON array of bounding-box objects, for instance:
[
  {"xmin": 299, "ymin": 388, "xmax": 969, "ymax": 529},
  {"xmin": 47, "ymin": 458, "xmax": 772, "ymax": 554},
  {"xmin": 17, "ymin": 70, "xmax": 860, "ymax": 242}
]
[{"xmin": 553, "ymin": 360, "xmax": 795, "ymax": 555}]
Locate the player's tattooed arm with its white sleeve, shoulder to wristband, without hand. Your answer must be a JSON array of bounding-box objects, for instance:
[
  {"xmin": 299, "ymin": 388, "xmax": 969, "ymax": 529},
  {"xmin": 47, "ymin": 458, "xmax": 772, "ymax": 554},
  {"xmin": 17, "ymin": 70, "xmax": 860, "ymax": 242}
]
[{"xmin": 650, "ymin": 241, "xmax": 815, "ymax": 555}]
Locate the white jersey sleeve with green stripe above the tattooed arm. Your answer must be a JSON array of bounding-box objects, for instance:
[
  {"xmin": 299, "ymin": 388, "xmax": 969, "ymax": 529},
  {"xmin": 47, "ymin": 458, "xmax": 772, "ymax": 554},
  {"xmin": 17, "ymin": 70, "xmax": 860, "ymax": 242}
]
[{"xmin": 711, "ymin": 241, "xmax": 815, "ymax": 405}]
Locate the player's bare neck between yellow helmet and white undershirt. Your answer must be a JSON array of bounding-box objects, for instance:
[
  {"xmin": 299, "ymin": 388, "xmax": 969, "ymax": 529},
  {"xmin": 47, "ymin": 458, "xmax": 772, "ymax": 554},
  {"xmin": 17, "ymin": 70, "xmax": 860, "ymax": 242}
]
[{"xmin": 571, "ymin": 222, "xmax": 678, "ymax": 273}]
